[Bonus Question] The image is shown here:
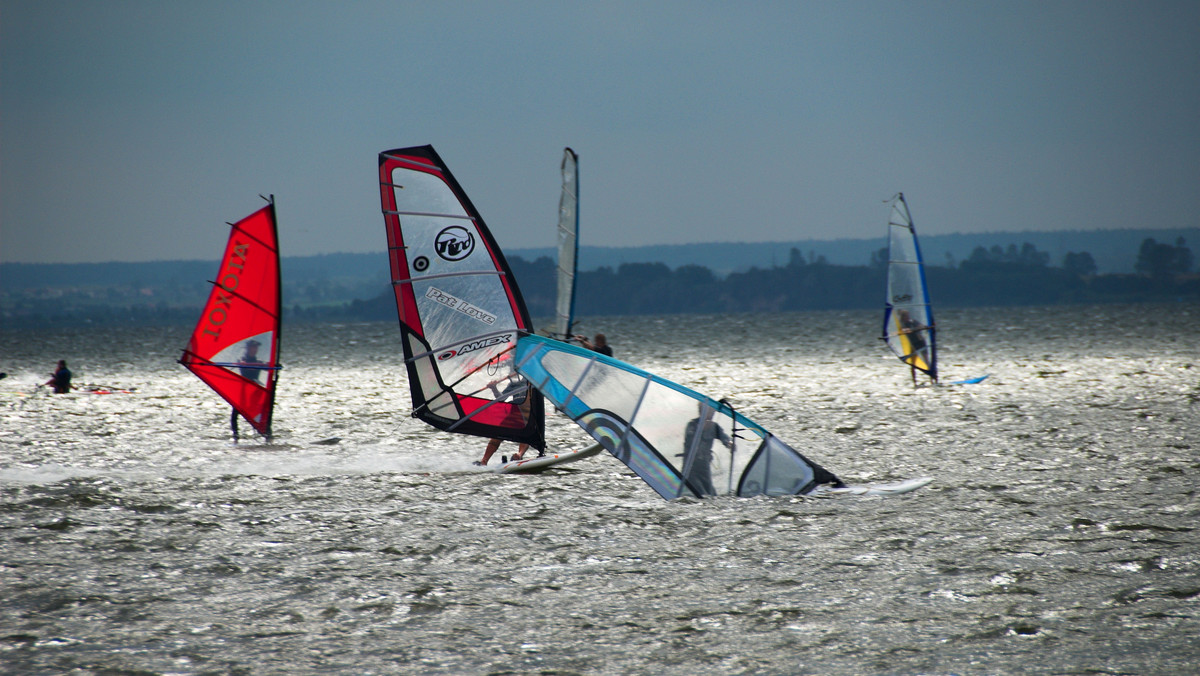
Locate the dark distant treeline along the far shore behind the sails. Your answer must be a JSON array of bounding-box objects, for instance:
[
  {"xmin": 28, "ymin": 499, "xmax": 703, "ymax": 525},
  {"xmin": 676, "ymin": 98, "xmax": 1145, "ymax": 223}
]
[{"xmin": 2, "ymin": 238, "xmax": 1200, "ymax": 328}]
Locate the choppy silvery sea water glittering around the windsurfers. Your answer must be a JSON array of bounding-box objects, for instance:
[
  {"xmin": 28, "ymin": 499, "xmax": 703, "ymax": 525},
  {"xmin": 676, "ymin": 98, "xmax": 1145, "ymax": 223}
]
[{"xmin": 0, "ymin": 304, "xmax": 1200, "ymax": 675}]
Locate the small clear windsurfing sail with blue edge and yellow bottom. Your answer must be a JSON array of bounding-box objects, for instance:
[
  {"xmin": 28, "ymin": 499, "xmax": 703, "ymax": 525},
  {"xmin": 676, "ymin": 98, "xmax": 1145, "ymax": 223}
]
[{"xmin": 882, "ymin": 192, "xmax": 937, "ymax": 383}]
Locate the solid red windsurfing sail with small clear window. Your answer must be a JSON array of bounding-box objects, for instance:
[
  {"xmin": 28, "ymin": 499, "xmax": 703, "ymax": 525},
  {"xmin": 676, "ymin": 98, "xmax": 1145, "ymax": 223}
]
[{"xmin": 179, "ymin": 196, "xmax": 281, "ymax": 438}]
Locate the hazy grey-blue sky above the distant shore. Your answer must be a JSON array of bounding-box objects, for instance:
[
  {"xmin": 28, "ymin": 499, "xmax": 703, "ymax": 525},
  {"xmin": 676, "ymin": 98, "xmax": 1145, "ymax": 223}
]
[{"xmin": 0, "ymin": 0, "xmax": 1200, "ymax": 264}]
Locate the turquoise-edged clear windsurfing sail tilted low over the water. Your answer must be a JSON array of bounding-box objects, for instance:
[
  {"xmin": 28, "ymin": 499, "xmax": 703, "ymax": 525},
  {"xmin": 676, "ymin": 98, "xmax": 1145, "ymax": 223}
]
[{"xmin": 516, "ymin": 335, "xmax": 842, "ymax": 499}]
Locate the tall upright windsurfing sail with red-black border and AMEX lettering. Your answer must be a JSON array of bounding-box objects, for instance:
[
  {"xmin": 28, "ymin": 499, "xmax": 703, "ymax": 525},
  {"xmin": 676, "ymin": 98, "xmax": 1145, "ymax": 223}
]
[{"xmin": 379, "ymin": 145, "xmax": 546, "ymax": 450}]
